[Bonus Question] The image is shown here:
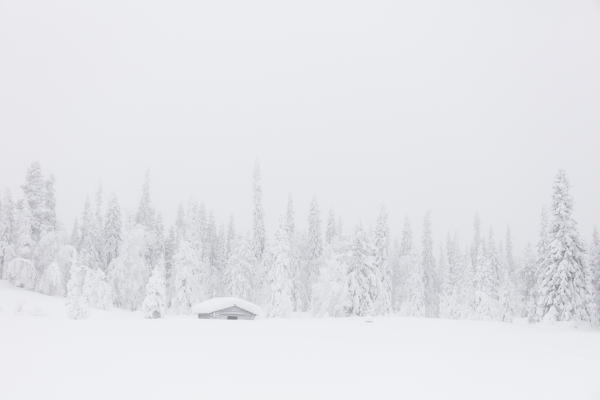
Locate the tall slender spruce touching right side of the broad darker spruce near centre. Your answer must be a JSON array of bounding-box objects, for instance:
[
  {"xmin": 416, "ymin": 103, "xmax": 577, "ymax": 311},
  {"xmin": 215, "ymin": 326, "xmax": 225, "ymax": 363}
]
[{"xmin": 373, "ymin": 207, "xmax": 392, "ymax": 314}]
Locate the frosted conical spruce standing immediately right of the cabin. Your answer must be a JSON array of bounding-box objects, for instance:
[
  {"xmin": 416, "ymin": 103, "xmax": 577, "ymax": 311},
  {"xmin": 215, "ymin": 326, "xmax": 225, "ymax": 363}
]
[{"xmin": 266, "ymin": 220, "xmax": 293, "ymax": 317}]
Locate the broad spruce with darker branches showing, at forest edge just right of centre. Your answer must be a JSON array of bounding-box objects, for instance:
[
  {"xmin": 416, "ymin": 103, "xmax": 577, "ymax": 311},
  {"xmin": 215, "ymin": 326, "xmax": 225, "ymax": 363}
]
[{"xmin": 346, "ymin": 225, "xmax": 379, "ymax": 316}]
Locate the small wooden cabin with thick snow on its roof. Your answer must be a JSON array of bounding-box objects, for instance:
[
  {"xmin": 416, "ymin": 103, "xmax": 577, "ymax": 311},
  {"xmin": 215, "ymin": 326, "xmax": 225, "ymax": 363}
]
[{"xmin": 192, "ymin": 297, "xmax": 262, "ymax": 320}]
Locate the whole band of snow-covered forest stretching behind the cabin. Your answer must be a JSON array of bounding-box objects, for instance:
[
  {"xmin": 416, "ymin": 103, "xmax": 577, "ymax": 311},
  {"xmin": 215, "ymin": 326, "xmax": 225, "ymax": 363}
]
[{"xmin": 0, "ymin": 163, "xmax": 600, "ymax": 322}]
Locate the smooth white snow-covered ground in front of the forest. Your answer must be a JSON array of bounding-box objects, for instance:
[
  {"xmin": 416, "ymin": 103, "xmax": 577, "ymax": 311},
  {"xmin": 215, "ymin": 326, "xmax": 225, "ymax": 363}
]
[{"xmin": 0, "ymin": 282, "xmax": 600, "ymax": 400}]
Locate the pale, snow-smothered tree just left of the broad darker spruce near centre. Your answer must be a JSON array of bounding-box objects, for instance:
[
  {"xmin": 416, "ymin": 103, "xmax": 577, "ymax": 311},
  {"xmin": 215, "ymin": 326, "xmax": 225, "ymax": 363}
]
[{"xmin": 311, "ymin": 241, "xmax": 350, "ymax": 317}]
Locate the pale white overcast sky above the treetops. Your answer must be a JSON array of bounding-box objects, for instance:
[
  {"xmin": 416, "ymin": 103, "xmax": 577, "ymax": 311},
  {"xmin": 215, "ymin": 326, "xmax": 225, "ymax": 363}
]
[{"xmin": 0, "ymin": 0, "xmax": 600, "ymax": 250}]
